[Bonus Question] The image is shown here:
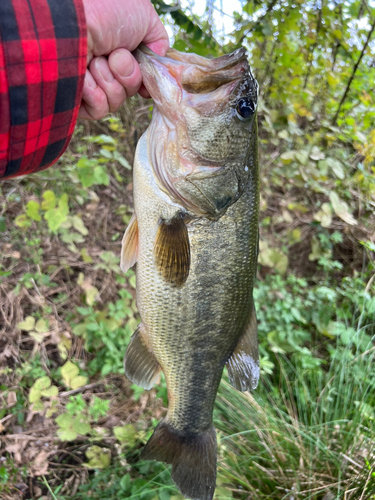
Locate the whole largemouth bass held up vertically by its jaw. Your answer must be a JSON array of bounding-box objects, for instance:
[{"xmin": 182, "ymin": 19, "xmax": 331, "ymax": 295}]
[{"xmin": 121, "ymin": 45, "xmax": 260, "ymax": 500}]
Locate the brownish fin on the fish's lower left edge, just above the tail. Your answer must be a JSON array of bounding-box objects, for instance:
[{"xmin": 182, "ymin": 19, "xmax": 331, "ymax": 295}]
[{"xmin": 124, "ymin": 323, "xmax": 161, "ymax": 390}]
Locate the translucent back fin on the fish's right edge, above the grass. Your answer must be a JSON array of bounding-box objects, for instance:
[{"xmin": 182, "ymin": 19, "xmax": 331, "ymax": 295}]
[{"xmin": 226, "ymin": 307, "xmax": 260, "ymax": 391}]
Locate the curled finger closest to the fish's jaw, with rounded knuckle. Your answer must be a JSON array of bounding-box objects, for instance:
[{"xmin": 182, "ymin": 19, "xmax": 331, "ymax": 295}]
[{"xmin": 108, "ymin": 49, "xmax": 142, "ymax": 97}]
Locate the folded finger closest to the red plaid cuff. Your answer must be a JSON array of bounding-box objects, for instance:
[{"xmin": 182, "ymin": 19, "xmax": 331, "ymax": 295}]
[{"xmin": 79, "ymin": 69, "xmax": 109, "ymax": 120}]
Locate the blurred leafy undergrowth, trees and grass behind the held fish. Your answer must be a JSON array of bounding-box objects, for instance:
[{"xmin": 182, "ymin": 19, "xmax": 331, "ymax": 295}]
[{"xmin": 0, "ymin": 0, "xmax": 375, "ymax": 500}]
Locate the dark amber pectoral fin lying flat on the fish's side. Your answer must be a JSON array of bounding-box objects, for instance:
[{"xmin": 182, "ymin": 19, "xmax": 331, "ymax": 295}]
[{"xmin": 154, "ymin": 214, "xmax": 190, "ymax": 286}]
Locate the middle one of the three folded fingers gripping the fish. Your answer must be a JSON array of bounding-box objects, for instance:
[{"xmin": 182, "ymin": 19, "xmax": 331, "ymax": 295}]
[{"xmin": 90, "ymin": 57, "xmax": 126, "ymax": 113}]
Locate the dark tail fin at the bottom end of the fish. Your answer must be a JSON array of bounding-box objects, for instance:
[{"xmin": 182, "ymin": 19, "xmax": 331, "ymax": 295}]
[{"xmin": 141, "ymin": 420, "xmax": 216, "ymax": 500}]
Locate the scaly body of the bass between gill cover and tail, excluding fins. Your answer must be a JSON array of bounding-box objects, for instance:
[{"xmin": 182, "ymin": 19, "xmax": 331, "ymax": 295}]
[{"xmin": 134, "ymin": 131, "xmax": 258, "ymax": 435}]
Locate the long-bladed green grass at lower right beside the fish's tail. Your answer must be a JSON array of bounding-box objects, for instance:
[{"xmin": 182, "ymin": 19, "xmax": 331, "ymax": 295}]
[{"xmin": 216, "ymin": 338, "xmax": 375, "ymax": 500}]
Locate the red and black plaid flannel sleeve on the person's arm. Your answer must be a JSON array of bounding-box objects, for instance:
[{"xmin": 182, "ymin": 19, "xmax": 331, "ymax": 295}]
[{"xmin": 0, "ymin": 0, "xmax": 87, "ymax": 178}]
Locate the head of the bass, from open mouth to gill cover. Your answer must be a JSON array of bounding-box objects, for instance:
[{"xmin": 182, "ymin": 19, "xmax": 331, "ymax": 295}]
[{"xmin": 135, "ymin": 46, "xmax": 258, "ymax": 218}]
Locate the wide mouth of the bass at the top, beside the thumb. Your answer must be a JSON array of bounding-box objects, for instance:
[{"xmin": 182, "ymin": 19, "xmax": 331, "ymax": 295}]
[{"xmin": 133, "ymin": 44, "xmax": 251, "ymax": 98}]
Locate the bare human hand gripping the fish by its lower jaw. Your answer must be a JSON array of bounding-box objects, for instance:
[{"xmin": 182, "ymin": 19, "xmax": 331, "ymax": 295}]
[{"xmin": 78, "ymin": 0, "xmax": 169, "ymax": 120}]
